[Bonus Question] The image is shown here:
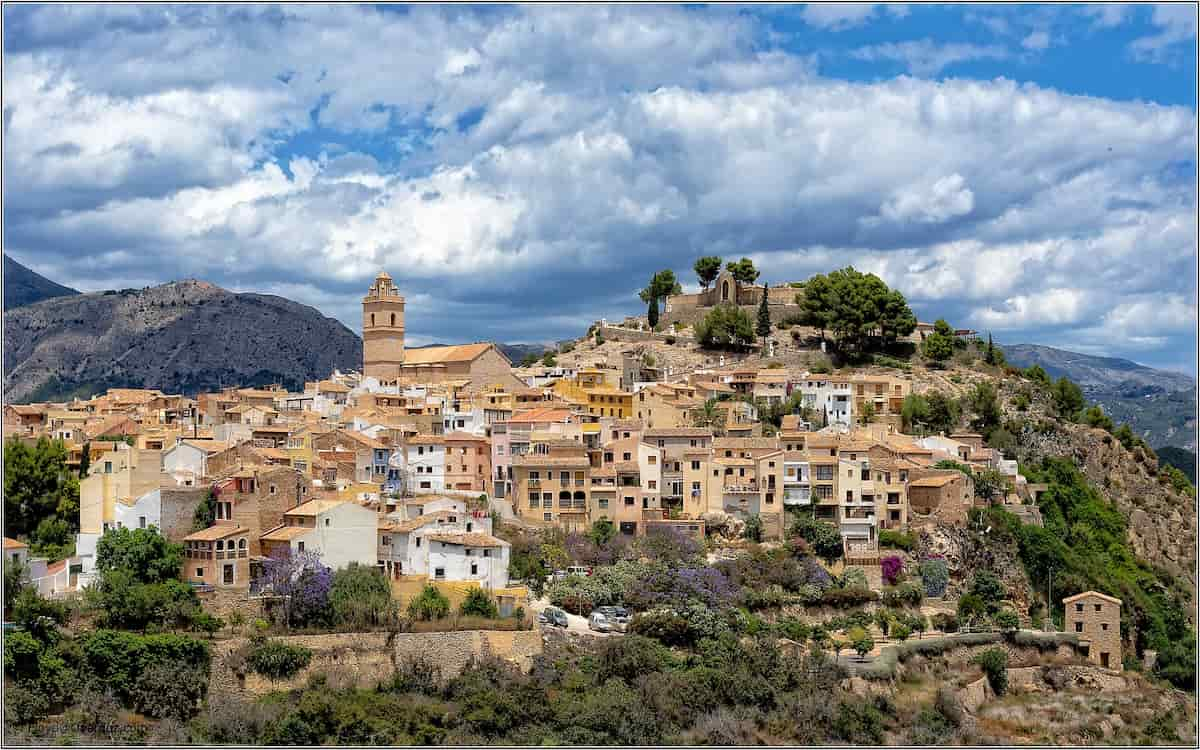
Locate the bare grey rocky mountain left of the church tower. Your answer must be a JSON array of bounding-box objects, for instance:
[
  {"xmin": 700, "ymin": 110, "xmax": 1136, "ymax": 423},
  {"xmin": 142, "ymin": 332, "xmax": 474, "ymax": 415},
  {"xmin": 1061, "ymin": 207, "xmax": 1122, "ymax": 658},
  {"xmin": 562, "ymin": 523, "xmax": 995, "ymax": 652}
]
[{"xmin": 4, "ymin": 280, "xmax": 362, "ymax": 402}]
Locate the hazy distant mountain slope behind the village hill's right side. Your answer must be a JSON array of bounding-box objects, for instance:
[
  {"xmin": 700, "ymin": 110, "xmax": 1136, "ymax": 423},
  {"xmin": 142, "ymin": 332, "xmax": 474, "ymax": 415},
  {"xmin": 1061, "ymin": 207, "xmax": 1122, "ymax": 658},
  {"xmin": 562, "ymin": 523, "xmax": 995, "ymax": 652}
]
[{"xmin": 1003, "ymin": 344, "xmax": 1196, "ymax": 452}]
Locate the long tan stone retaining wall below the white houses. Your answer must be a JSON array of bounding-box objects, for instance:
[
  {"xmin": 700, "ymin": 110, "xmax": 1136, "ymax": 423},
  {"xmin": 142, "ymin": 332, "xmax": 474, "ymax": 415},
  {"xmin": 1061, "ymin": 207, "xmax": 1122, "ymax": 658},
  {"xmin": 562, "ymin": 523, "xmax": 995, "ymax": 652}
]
[{"xmin": 209, "ymin": 630, "xmax": 542, "ymax": 695}]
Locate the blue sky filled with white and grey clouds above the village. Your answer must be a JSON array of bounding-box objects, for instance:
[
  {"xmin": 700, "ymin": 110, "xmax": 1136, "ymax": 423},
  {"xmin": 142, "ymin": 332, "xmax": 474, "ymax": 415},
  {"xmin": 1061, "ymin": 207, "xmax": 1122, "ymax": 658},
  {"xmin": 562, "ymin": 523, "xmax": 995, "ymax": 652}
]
[{"xmin": 4, "ymin": 4, "xmax": 1196, "ymax": 373}]
